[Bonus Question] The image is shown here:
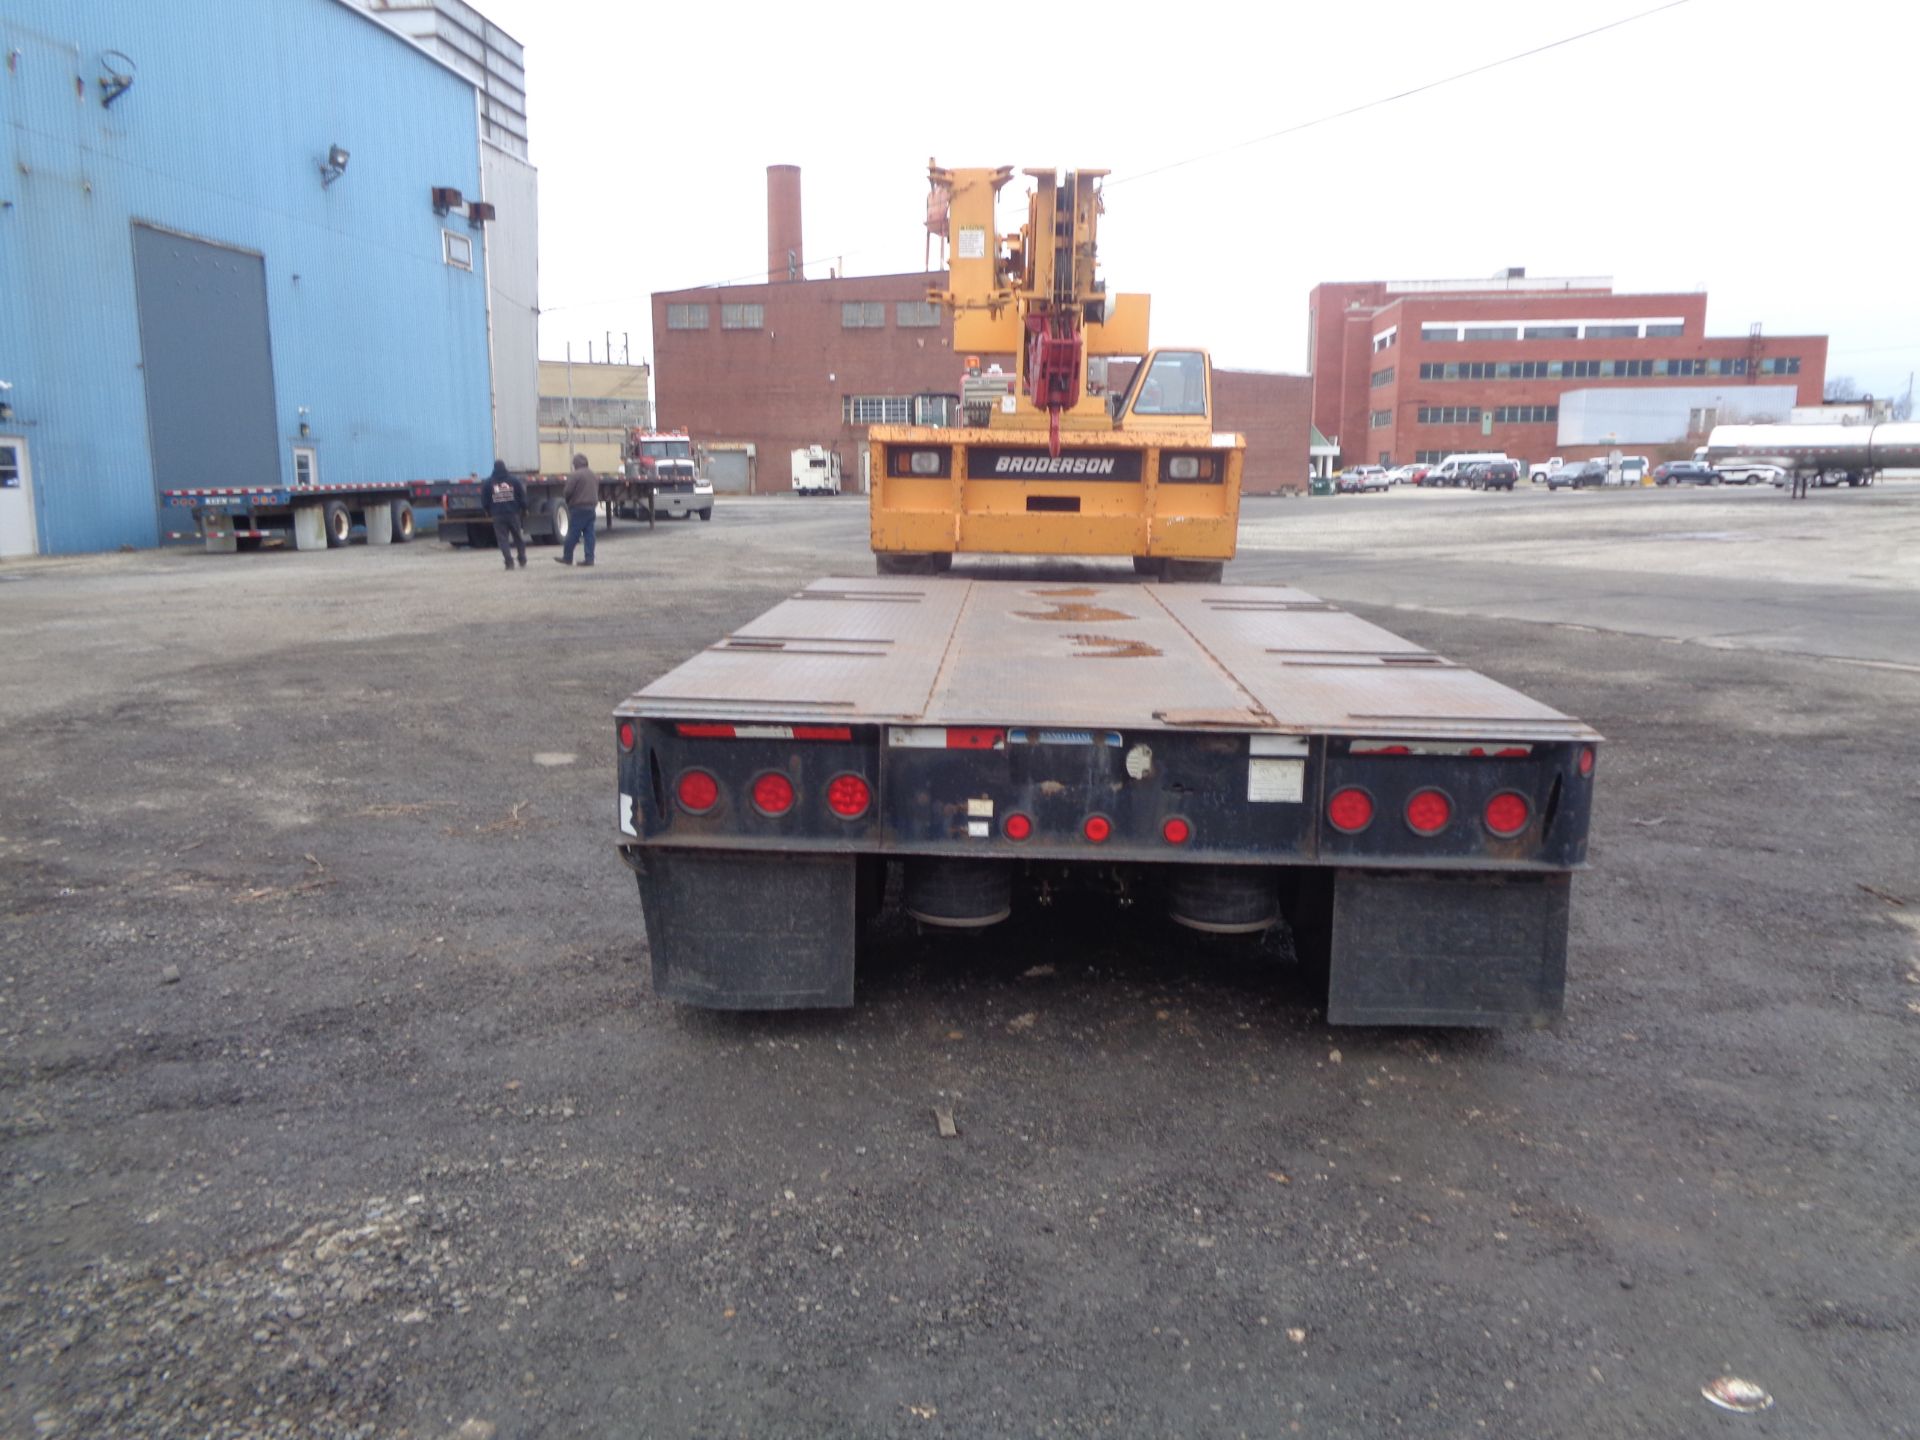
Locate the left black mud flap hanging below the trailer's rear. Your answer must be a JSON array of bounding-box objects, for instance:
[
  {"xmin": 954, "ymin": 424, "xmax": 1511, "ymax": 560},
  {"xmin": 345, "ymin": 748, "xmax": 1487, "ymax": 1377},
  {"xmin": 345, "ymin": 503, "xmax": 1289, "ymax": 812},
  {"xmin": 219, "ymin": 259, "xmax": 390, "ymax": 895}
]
[{"xmin": 624, "ymin": 849, "xmax": 858, "ymax": 1010}]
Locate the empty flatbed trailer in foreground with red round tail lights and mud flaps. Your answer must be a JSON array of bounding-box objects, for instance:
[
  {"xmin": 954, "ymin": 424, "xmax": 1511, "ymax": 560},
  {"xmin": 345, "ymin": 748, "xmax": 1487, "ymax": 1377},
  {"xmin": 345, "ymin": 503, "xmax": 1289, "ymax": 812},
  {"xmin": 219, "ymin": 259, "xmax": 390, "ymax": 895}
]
[{"xmin": 614, "ymin": 578, "xmax": 1601, "ymax": 1025}]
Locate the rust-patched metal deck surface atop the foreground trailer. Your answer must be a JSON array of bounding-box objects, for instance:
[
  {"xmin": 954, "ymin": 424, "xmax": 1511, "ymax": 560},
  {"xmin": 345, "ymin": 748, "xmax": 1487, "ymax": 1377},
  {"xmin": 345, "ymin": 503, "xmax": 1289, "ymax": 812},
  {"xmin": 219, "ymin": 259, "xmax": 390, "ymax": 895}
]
[{"xmin": 620, "ymin": 576, "xmax": 1596, "ymax": 741}]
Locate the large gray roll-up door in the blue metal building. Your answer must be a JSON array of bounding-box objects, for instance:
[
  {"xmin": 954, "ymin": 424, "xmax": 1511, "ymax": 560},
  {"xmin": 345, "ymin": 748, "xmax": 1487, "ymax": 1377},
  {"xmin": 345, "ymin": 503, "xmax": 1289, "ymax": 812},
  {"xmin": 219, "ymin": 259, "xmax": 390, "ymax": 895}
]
[{"xmin": 132, "ymin": 225, "xmax": 280, "ymax": 510}]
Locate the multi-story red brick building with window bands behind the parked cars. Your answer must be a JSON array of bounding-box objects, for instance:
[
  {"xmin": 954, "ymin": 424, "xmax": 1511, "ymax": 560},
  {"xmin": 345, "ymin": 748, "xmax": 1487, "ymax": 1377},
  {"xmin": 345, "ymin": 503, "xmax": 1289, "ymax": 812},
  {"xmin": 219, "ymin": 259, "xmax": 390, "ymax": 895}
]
[{"xmin": 1308, "ymin": 271, "xmax": 1826, "ymax": 465}]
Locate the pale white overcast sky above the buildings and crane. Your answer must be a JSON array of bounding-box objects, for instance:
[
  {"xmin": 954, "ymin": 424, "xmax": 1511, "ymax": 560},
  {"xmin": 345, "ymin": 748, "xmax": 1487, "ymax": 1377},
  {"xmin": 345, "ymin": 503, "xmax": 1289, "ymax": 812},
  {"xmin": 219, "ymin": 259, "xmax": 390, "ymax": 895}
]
[{"xmin": 480, "ymin": 0, "xmax": 1920, "ymax": 394}]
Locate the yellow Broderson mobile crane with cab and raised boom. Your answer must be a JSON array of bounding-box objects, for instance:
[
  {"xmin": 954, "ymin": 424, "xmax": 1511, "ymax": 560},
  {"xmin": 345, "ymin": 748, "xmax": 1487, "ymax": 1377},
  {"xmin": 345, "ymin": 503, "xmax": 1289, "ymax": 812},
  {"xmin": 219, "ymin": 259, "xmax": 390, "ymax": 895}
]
[{"xmin": 870, "ymin": 163, "xmax": 1246, "ymax": 580}]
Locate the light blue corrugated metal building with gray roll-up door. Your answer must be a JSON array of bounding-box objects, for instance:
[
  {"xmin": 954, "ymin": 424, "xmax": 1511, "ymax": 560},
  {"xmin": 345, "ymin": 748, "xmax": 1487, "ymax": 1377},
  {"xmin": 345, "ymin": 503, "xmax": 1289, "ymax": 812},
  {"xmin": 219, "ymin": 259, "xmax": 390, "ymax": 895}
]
[{"xmin": 0, "ymin": 0, "xmax": 492, "ymax": 553}]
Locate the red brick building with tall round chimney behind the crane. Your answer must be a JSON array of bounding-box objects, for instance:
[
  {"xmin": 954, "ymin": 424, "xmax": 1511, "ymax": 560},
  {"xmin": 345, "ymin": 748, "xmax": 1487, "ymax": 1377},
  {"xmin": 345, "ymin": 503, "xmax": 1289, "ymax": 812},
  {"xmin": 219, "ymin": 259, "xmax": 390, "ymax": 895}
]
[{"xmin": 653, "ymin": 165, "xmax": 1311, "ymax": 493}]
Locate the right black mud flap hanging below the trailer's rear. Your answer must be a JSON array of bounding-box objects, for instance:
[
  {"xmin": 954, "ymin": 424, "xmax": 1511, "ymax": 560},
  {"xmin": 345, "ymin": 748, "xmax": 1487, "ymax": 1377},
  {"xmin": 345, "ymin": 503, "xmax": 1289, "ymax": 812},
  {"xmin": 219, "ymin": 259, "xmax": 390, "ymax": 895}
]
[{"xmin": 1327, "ymin": 870, "xmax": 1572, "ymax": 1025}]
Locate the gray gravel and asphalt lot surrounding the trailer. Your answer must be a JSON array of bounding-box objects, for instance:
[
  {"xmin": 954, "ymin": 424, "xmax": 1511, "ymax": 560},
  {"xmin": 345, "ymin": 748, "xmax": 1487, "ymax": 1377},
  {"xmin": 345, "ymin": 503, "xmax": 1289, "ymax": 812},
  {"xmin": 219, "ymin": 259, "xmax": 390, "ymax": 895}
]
[{"xmin": 0, "ymin": 482, "xmax": 1920, "ymax": 1440}]
